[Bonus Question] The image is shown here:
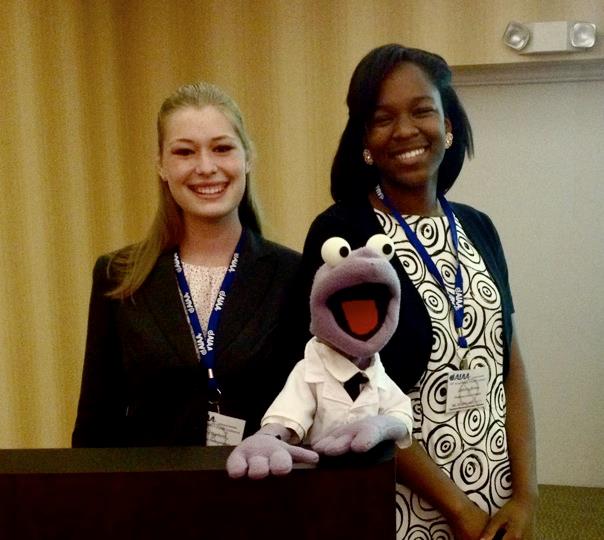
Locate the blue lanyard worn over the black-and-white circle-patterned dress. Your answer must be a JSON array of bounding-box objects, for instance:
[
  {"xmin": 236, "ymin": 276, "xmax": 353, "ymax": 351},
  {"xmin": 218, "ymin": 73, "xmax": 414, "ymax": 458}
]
[{"xmin": 375, "ymin": 185, "xmax": 468, "ymax": 349}]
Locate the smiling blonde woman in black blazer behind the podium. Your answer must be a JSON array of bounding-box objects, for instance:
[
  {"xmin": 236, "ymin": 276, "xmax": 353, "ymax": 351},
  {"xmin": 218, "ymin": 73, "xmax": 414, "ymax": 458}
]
[{"xmin": 72, "ymin": 83, "xmax": 300, "ymax": 447}]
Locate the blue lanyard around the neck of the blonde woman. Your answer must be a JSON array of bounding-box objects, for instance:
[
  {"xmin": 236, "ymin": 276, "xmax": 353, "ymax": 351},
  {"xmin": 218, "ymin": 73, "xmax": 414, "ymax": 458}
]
[{"xmin": 174, "ymin": 230, "xmax": 244, "ymax": 403}]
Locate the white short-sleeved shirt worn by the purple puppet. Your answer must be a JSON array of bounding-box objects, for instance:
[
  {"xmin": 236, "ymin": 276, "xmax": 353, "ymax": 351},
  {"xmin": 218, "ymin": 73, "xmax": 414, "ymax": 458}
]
[{"xmin": 262, "ymin": 337, "xmax": 413, "ymax": 448}]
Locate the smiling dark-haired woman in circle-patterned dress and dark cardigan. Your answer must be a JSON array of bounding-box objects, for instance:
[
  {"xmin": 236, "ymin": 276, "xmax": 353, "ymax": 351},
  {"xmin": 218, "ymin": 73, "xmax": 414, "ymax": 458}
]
[{"xmin": 302, "ymin": 44, "xmax": 537, "ymax": 540}]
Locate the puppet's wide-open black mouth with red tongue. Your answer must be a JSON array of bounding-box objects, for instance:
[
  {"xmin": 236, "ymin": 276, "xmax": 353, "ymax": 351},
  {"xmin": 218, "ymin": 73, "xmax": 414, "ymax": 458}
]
[{"xmin": 327, "ymin": 283, "xmax": 392, "ymax": 341}]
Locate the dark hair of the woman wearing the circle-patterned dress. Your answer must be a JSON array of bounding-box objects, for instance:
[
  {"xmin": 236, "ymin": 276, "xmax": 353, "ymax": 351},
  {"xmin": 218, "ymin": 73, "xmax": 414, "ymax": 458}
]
[{"xmin": 331, "ymin": 43, "xmax": 474, "ymax": 201}]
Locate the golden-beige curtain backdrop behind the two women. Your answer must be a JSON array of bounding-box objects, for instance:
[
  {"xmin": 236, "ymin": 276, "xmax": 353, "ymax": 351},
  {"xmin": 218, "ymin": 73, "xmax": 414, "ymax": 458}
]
[{"xmin": 0, "ymin": 0, "xmax": 603, "ymax": 448}]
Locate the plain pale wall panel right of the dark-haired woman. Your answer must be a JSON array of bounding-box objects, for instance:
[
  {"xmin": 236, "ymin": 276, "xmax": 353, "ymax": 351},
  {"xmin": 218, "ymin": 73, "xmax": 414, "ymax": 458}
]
[{"xmin": 449, "ymin": 75, "xmax": 604, "ymax": 487}]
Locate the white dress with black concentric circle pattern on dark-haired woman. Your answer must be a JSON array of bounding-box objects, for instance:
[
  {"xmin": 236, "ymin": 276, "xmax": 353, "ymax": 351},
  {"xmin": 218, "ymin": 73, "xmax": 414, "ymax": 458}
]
[{"xmin": 376, "ymin": 210, "xmax": 512, "ymax": 540}]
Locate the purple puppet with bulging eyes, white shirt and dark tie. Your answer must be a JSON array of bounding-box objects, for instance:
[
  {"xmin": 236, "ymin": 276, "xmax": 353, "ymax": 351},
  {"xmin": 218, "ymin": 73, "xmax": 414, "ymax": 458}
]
[{"xmin": 227, "ymin": 234, "xmax": 413, "ymax": 478}]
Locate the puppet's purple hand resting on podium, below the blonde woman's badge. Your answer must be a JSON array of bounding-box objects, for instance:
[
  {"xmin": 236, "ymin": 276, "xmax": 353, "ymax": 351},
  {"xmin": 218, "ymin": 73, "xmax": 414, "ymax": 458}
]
[{"xmin": 226, "ymin": 428, "xmax": 319, "ymax": 479}]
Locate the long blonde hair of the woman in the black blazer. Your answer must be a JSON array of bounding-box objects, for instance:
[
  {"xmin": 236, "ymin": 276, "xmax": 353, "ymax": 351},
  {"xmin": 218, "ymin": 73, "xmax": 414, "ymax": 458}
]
[{"xmin": 107, "ymin": 82, "xmax": 261, "ymax": 299}]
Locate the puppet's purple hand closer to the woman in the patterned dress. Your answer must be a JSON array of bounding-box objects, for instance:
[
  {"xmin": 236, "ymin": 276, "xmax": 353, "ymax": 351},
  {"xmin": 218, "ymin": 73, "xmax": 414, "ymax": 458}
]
[{"xmin": 312, "ymin": 415, "xmax": 407, "ymax": 456}]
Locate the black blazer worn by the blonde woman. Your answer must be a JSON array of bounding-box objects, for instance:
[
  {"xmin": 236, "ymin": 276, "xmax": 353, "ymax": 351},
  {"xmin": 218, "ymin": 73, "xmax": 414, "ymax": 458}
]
[{"xmin": 72, "ymin": 231, "xmax": 300, "ymax": 447}]
